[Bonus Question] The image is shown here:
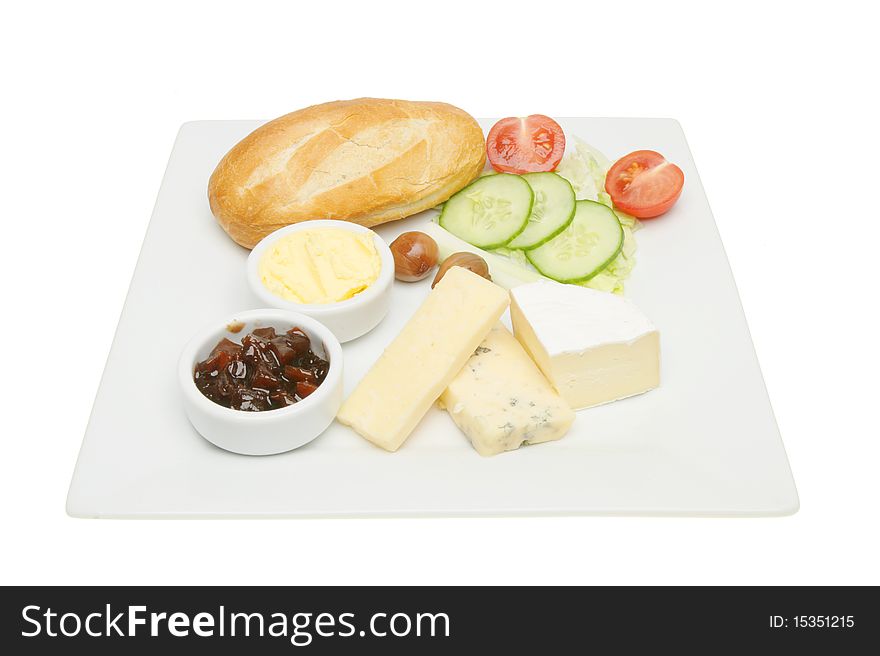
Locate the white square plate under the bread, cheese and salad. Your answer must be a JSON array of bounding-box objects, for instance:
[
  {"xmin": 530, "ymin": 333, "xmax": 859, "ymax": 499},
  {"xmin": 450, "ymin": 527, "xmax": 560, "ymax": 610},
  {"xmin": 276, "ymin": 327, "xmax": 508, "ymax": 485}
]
[{"xmin": 67, "ymin": 118, "xmax": 798, "ymax": 518}]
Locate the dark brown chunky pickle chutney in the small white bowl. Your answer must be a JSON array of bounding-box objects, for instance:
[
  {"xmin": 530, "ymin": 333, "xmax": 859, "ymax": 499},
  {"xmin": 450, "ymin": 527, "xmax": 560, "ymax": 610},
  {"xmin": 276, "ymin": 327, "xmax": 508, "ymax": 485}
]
[{"xmin": 193, "ymin": 328, "xmax": 330, "ymax": 412}]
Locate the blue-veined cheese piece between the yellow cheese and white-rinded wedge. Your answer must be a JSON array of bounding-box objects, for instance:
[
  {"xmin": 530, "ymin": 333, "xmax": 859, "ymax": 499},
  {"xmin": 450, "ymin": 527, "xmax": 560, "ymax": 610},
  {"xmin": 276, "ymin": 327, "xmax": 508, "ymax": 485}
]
[{"xmin": 440, "ymin": 324, "xmax": 575, "ymax": 456}]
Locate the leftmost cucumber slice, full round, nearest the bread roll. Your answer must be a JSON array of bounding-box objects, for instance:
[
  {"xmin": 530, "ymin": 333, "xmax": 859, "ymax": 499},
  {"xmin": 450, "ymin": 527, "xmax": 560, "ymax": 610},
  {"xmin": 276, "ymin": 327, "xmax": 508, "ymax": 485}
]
[{"xmin": 440, "ymin": 173, "xmax": 535, "ymax": 249}]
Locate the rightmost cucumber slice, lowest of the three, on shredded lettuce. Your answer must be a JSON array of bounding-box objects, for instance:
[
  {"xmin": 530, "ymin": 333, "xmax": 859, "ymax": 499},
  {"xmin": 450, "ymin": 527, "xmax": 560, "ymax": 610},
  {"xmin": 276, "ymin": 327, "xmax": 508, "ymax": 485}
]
[{"xmin": 526, "ymin": 200, "xmax": 623, "ymax": 282}]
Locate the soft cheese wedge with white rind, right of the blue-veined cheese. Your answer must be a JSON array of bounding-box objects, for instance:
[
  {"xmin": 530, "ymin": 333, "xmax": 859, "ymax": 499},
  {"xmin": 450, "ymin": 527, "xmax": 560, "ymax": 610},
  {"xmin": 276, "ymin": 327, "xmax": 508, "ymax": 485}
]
[{"xmin": 510, "ymin": 280, "xmax": 660, "ymax": 410}]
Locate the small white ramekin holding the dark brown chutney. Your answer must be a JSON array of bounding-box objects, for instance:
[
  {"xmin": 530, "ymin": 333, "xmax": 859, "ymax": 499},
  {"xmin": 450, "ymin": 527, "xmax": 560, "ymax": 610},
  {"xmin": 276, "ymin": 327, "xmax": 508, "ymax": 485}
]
[{"xmin": 178, "ymin": 310, "xmax": 342, "ymax": 456}]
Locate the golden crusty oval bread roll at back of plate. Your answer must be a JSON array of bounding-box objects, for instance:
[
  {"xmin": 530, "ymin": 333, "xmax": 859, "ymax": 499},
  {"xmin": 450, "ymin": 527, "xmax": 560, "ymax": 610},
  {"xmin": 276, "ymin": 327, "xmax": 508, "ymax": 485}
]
[{"xmin": 208, "ymin": 98, "xmax": 486, "ymax": 248}]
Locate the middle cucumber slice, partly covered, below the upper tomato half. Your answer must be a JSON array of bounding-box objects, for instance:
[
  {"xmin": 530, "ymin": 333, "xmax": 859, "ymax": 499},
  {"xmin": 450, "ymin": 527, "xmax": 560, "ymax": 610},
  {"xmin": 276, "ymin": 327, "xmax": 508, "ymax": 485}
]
[{"xmin": 507, "ymin": 172, "xmax": 574, "ymax": 250}]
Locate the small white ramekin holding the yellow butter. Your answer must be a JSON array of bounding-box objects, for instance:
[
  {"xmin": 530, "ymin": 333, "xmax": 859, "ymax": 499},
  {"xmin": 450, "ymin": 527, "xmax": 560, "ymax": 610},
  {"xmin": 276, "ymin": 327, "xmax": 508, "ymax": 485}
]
[{"xmin": 247, "ymin": 220, "xmax": 394, "ymax": 342}]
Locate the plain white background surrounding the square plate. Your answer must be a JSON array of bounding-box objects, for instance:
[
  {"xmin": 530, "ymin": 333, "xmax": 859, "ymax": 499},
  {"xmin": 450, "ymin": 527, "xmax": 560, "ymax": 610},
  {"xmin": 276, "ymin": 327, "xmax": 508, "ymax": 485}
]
[{"xmin": 0, "ymin": 0, "xmax": 880, "ymax": 584}]
